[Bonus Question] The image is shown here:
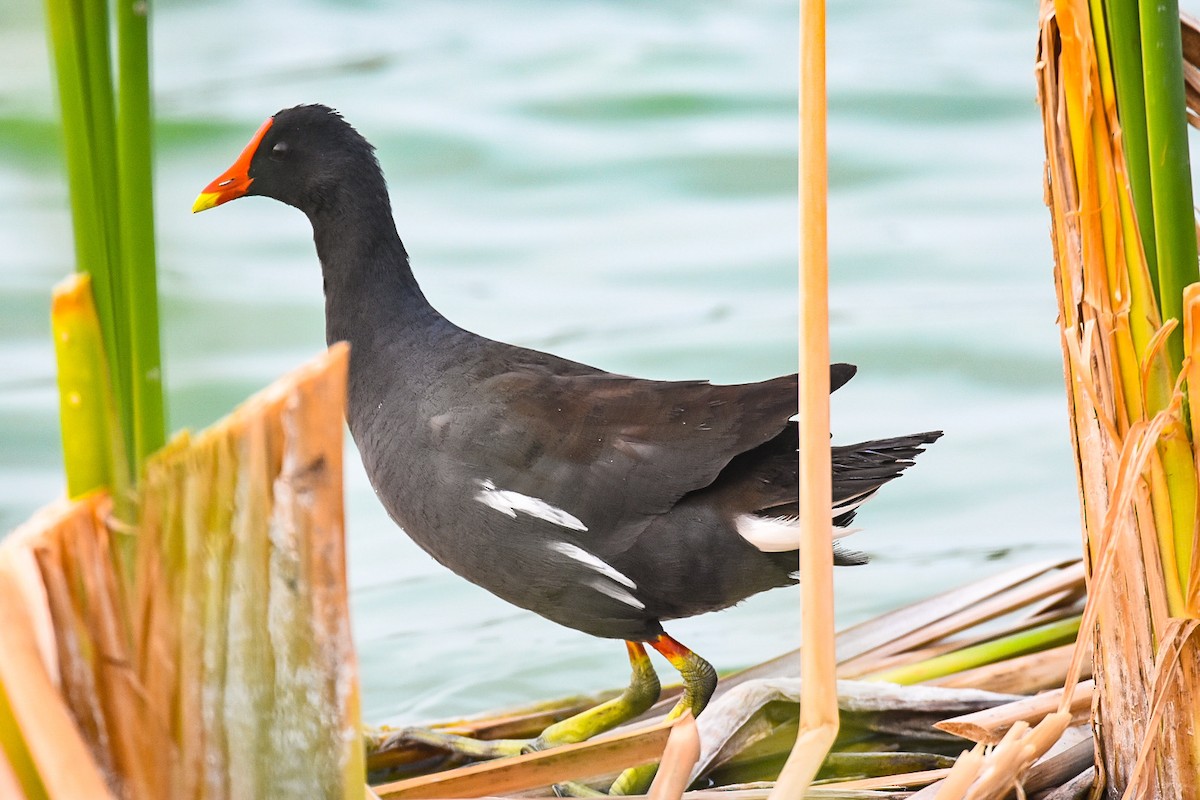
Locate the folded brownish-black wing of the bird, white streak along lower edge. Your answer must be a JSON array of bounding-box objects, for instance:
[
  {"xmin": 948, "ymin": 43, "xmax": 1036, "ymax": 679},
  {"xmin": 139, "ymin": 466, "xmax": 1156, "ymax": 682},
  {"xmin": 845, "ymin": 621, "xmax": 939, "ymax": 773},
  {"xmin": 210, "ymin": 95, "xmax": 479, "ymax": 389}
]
[{"xmin": 436, "ymin": 365, "xmax": 853, "ymax": 542}]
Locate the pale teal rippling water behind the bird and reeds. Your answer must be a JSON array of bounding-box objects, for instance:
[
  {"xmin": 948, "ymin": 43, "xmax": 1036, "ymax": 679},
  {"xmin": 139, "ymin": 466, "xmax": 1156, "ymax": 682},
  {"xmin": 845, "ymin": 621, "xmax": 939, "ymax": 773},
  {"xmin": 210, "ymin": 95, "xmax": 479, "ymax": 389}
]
[{"xmin": 0, "ymin": 0, "xmax": 1079, "ymax": 721}]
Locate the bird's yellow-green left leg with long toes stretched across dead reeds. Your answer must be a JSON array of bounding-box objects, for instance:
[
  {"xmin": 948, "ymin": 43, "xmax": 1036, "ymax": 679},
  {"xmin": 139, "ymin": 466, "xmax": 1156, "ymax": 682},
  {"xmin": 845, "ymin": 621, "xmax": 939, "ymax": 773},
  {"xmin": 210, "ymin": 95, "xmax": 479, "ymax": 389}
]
[{"xmin": 379, "ymin": 642, "xmax": 659, "ymax": 759}]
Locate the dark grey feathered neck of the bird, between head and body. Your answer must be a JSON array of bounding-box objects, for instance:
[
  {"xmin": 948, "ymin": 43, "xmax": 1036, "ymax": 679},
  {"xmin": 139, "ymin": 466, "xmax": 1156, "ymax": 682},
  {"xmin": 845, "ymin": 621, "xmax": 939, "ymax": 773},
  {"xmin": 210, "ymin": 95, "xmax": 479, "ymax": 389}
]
[{"xmin": 307, "ymin": 187, "xmax": 445, "ymax": 351}]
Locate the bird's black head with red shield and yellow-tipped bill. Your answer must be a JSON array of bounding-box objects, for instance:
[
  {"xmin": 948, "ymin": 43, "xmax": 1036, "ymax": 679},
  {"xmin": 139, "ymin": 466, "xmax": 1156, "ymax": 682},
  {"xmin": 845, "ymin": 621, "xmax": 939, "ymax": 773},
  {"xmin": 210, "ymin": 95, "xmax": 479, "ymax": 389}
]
[{"xmin": 192, "ymin": 106, "xmax": 386, "ymax": 216}]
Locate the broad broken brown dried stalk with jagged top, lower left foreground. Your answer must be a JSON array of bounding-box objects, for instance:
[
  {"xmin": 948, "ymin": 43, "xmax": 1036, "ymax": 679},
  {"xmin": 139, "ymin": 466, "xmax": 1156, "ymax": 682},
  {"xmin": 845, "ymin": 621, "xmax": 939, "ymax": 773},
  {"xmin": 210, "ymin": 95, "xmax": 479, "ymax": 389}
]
[{"xmin": 0, "ymin": 345, "xmax": 364, "ymax": 800}]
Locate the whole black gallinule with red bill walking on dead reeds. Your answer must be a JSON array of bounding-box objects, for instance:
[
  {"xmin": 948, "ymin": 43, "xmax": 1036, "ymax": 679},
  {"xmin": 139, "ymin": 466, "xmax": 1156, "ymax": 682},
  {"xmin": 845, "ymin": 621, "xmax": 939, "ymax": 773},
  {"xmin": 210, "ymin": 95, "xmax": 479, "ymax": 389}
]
[{"xmin": 193, "ymin": 106, "xmax": 941, "ymax": 791}]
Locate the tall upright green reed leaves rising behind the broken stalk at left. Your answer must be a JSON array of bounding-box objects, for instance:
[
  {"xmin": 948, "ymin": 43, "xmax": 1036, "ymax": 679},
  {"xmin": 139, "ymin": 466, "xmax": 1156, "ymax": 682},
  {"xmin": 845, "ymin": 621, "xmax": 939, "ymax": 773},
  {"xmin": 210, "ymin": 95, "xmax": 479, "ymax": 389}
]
[{"xmin": 46, "ymin": 0, "xmax": 166, "ymax": 488}]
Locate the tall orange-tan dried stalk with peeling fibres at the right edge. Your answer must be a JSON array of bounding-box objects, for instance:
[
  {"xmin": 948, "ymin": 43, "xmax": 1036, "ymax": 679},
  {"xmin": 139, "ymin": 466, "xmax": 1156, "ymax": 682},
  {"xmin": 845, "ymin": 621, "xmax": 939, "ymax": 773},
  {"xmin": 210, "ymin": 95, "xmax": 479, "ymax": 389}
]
[{"xmin": 1038, "ymin": 0, "xmax": 1200, "ymax": 798}]
